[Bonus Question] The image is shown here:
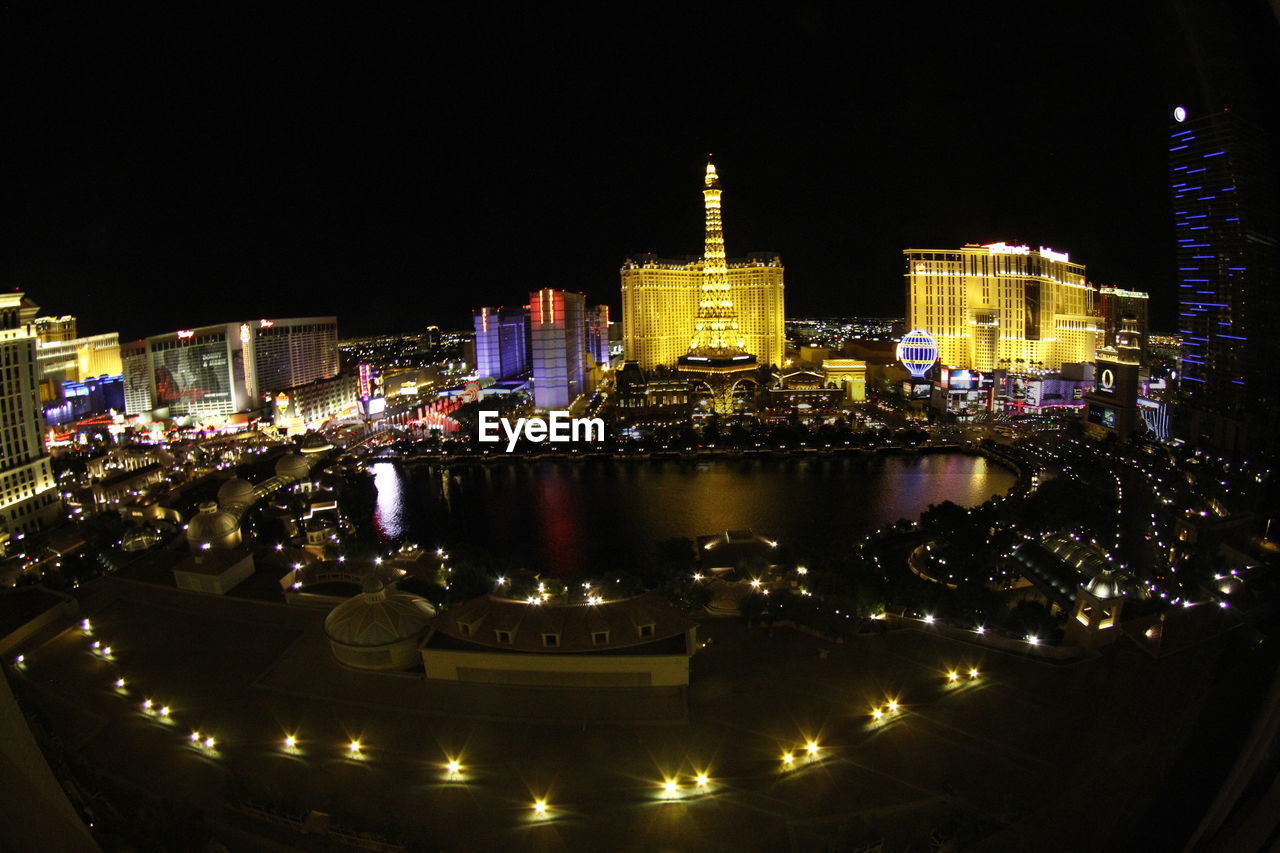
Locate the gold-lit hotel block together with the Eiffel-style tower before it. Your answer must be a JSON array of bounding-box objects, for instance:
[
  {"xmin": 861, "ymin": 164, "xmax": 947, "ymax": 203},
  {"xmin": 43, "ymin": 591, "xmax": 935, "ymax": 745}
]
[{"xmin": 621, "ymin": 164, "xmax": 785, "ymax": 370}]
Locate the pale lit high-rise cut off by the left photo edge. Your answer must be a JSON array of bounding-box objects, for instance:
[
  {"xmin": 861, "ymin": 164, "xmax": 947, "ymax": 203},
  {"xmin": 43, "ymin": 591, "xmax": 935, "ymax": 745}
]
[{"xmin": 0, "ymin": 293, "xmax": 60, "ymax": 537}]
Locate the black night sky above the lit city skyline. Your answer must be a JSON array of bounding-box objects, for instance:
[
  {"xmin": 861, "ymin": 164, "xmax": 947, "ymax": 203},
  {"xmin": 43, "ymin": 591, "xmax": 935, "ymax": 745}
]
[{"xmin": 10, "ymin": 0, "xmax": 1280, "ymax": 338}]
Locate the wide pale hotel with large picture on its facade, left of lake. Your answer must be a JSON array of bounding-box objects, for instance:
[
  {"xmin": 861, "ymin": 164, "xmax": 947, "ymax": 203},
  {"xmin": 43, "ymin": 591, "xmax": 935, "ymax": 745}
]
[{"xmin": 120, "ymin": 316, "xmax": 338, "ymax": 418}]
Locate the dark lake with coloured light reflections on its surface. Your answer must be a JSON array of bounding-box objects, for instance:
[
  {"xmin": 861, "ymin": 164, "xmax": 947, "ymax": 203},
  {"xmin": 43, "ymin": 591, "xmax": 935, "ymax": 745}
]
[{"xmin": 370, "ymin": 453, "xmax": 1015, "ymax": 576}]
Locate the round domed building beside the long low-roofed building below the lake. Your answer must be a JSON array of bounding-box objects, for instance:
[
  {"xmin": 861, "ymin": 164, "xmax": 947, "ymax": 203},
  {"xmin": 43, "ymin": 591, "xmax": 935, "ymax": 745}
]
[{"xmin": 324, "ymin": 576, "xmax": 435, "ymax": 670}]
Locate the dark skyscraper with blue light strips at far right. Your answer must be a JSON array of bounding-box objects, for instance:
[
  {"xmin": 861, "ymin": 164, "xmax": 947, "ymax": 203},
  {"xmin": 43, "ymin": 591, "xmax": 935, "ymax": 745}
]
[{"xmin": 1169, "ymin": 106, "xmax": 1280, "ymax": 451}]
